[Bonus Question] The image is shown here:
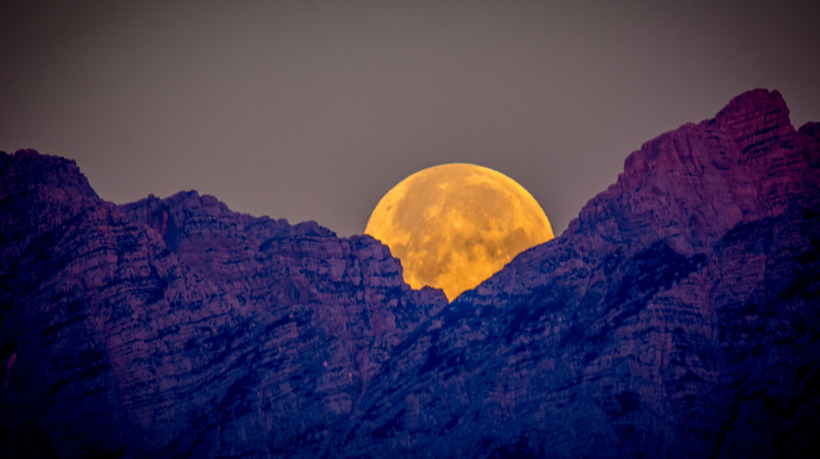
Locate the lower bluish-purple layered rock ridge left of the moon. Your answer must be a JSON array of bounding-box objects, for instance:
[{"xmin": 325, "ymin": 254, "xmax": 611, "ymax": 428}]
[{"xmin": 0, "ymin": 152, "xmax": 446, "ymax": 457}]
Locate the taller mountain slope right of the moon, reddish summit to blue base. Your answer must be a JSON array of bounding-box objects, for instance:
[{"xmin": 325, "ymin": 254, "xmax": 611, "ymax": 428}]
[{"xmin": 338, "ymin": 91, "xmax": 820, "ymax": 457}]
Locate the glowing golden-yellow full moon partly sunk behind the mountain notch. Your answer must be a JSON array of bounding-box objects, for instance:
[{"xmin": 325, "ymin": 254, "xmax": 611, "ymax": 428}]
[{"xmin": 364, "ymin": 163, "xmax": 553, "ymax": 300}]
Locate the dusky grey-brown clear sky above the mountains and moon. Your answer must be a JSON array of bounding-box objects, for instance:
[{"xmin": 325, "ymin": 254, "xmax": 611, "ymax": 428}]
[{"xmin": 0, "ymin": 0, "xmax": 820, "ymax": 236}]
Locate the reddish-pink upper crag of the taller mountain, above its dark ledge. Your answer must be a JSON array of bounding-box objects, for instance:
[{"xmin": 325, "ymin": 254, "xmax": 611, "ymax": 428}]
[{"xmin": 567, "ymin": 89, "xmax": 818, "ymax": 262}]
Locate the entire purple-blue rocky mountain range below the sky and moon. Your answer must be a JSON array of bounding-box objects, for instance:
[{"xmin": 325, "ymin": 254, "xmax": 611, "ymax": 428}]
[{"xmin": 0, "ymin": 90, "xmax": 820, "ymax": 457}]
